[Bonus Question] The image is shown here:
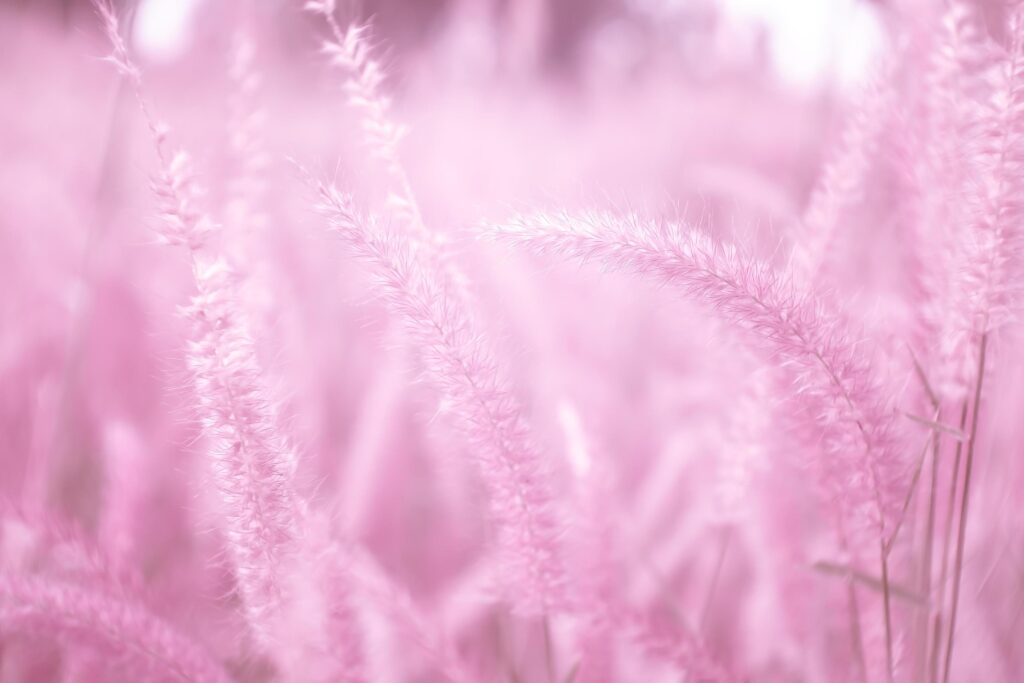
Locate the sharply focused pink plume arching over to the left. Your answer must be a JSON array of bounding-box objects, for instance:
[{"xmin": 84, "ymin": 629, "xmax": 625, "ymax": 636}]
[{"xmin": 486, "ymin": 213, "xmax": 905, "ymax": 539}]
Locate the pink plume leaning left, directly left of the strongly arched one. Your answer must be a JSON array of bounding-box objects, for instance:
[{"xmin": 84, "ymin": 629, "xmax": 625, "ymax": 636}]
[{"xmin": 317, "ymin": 184, "xmax": 565, "ymax": 614}]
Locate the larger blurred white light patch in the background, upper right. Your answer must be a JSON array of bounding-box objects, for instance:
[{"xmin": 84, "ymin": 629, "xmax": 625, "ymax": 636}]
[{"xmin": 721, "ymin": 0, "xmax": 885, "ymax": 87}]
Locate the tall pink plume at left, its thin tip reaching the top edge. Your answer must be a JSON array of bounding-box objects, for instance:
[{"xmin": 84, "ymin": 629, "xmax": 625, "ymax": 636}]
[{"xmin": 97, "ymin": 2, "xmax": 315, "ymax": 655}]
